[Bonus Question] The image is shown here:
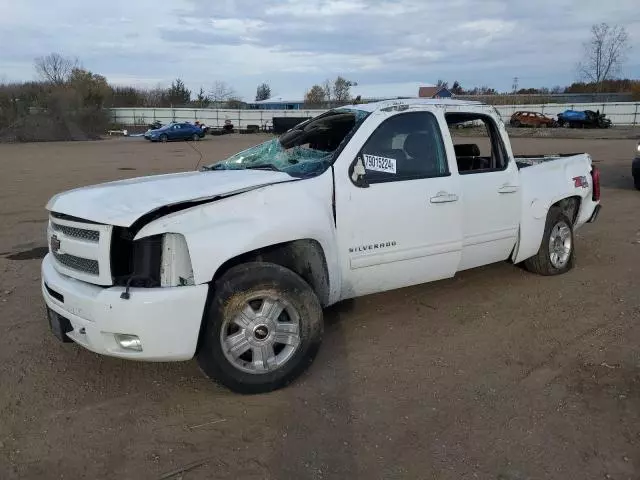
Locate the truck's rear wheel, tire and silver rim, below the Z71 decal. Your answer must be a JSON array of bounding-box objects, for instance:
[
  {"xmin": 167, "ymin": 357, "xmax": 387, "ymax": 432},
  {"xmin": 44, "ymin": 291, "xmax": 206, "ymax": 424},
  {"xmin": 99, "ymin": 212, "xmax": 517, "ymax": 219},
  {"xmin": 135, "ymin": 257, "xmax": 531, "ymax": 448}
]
[{"xmin": 524, "ymin": 207, "xmax": 574, "ymax": 275}]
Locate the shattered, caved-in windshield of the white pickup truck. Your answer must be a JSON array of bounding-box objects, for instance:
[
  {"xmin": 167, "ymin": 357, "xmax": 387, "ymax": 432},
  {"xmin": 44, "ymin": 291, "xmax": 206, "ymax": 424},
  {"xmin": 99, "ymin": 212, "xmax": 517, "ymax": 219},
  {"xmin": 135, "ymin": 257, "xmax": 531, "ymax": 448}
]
[{"xmin": 205, "ymin": 108, "xmax": 368, "ymax": 177}]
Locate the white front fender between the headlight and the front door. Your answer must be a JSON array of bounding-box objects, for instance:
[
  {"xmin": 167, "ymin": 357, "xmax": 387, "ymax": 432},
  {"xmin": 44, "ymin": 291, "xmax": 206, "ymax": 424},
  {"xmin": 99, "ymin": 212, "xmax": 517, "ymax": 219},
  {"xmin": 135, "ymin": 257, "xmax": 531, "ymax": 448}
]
[{"xmin": 135, "ymin": 174, "xmax": 339, "ymax": 297}]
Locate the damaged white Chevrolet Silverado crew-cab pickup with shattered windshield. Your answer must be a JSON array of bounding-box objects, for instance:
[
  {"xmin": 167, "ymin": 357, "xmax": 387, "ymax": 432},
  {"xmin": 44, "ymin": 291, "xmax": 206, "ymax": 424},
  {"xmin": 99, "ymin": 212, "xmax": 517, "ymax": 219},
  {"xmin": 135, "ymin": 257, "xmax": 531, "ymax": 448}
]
[{"xmin": 42, "ymin": 99, "xmax": 600, "ymax": 393}]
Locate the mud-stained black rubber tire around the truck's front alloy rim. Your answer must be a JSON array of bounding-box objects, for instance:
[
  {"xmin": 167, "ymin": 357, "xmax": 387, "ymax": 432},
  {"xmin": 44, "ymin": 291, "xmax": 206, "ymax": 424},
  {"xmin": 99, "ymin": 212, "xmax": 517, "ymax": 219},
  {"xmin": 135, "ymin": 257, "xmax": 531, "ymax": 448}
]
[{"xmin": 196, "ymin": 262, "xmax": 324, "ymax": 394}]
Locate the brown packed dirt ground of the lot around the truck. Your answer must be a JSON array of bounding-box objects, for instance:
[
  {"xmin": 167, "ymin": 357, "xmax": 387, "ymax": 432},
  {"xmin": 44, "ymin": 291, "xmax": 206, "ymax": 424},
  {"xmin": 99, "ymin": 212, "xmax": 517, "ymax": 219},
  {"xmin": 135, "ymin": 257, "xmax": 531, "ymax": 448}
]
[{"xmin": 0, "ymin": 135, "xmax": 640, "ymax": 480}]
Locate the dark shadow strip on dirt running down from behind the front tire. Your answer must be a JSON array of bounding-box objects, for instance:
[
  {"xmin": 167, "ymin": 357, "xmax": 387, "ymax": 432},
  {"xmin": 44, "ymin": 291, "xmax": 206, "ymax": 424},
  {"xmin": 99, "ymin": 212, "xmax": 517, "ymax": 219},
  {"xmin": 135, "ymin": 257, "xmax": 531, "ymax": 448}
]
[{"xmin": 267, "ymin": 300, "xmax": 361, "ymax": 478}]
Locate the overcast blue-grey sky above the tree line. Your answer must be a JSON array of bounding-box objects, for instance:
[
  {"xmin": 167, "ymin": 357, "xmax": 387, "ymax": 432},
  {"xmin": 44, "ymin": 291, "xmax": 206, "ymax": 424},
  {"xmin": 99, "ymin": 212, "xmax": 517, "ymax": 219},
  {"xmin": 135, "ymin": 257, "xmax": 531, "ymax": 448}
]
[{"xmin": 0, "ymin": 0, "xmax": 640, "ymax": 100}]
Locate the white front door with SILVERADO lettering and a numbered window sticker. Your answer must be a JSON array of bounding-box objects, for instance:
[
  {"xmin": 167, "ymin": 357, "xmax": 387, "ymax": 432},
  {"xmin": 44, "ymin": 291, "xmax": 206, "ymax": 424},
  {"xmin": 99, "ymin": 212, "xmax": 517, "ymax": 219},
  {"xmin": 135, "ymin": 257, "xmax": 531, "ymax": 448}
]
[{"xmin": 335, "ymin": 109, "xmax": 462, "ymax": 298}]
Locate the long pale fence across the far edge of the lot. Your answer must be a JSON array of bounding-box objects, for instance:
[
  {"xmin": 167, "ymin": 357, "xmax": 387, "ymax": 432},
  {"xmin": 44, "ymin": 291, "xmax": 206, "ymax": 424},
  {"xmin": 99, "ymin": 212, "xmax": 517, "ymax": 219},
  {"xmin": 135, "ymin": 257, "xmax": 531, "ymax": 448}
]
[{"xmin": 111, "ymin": 102, "xmax": 640, "ymax": 128}]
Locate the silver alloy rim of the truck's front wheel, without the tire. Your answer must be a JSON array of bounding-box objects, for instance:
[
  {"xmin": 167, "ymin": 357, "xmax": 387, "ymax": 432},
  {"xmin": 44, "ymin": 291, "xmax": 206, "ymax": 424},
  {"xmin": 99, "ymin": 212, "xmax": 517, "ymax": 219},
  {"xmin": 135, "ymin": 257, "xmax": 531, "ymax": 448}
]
[{"xmin": 220, "ymin": 294, "xmax": 300, "ymax": 374}]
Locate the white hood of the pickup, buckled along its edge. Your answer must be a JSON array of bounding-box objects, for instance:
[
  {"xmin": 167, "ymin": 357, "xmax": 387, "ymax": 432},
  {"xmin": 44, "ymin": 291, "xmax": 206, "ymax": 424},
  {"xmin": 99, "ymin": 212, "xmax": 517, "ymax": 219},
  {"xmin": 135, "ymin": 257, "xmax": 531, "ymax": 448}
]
[{"xmin": 47, "ymin": 170, "xmax": 297, "ymax": 227}]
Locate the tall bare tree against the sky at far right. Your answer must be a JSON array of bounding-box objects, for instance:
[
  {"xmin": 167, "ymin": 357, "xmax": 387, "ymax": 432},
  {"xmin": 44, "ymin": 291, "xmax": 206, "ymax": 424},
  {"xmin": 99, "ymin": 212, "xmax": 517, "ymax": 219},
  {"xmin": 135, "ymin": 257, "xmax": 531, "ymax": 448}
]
[{"xmin": 578, "ymin": 23, "xmax": 630, "ymax": 85}]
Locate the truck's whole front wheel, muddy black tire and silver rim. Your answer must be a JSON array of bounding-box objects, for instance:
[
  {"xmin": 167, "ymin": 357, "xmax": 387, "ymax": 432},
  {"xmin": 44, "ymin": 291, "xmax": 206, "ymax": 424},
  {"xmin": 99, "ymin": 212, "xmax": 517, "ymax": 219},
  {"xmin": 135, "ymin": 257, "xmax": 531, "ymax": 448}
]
[{"xmin": 197, "ymin": 262, "xmax": 323, "ymax": 393}]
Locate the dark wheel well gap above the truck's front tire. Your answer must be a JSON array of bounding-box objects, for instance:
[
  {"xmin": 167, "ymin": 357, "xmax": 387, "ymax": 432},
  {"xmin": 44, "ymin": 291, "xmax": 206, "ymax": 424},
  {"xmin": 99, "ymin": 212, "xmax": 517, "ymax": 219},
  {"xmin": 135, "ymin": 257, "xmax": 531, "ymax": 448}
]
[{"xmin": 213, "ymin": 239, "xmax": 329, "ymax": 306}]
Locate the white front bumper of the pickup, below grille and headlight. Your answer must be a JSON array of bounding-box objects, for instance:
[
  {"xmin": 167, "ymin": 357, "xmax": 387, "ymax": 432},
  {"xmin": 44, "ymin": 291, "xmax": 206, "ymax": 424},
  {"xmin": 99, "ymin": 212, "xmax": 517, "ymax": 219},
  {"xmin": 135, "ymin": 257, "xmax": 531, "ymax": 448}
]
[{"xmin": 42, "ymin": 254, "xmax": 208, "ymax": 362}]
